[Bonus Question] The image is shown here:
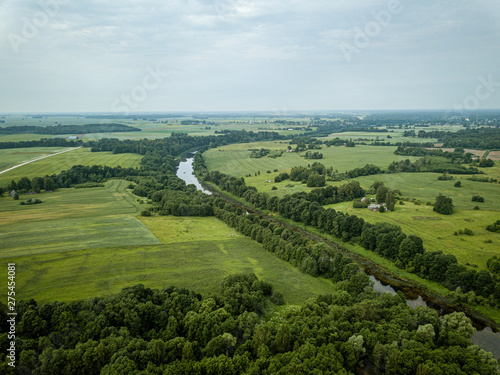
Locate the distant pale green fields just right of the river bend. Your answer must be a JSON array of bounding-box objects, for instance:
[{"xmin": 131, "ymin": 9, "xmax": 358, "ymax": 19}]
[{"xmin": 203, "ymin": 141, "xmax": 418, "ymax": 179}]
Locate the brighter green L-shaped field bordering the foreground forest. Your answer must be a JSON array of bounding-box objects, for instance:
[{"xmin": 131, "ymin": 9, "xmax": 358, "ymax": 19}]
[{"xmin": 9, "ymin": 217, "xmax": 332, "ymax": 304}]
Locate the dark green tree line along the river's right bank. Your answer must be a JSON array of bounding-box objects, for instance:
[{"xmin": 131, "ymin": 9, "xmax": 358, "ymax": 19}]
[{"xmin": 195, "ymin": 155, "xmax": 500, "ymax": 307}]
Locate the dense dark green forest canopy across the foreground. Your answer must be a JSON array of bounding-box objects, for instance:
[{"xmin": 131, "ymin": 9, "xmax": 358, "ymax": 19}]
[{"xmin": 0, "ymin": 274, "xmax": 498, "ymax": 375}]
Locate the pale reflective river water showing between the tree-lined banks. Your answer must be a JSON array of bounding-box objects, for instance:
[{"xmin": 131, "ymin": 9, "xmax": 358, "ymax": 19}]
[{"xmin": 177, "ymin": 157, "xmax": 500, "ymax": 360}]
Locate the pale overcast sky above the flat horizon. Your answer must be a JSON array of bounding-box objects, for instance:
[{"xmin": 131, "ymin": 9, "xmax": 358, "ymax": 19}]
[{"xmin": 0, "ymin": 0, "xmax": 500, "ymax": 114}]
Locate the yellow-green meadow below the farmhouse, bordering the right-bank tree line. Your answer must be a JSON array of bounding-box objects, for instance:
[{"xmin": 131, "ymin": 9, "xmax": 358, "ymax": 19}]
[{"xmin": 327, "ymin": 202, "xmax": 500, "ymax": 270}]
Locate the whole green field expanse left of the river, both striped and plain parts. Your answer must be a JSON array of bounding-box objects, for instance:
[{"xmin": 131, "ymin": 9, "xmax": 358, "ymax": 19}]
[{"xmin": 0, "ymin": 185, "xmax": 332, "ymax": 304}]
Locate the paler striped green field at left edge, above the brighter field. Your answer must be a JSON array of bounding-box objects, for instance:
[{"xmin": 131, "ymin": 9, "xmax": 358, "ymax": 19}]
[{"xmin": 0, "ymin": 180, "xmax": 159, "ymax": 259}]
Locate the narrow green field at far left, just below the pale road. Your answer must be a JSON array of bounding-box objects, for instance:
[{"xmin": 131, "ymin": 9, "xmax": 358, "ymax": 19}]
[{"xmin": 0, "ymin": 148, "xmax": 142, "ymax": 186}]
